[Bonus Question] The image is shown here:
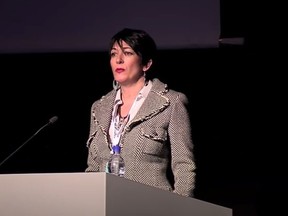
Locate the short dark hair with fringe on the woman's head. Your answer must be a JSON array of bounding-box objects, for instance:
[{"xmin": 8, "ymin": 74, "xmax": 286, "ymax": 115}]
[{"xmin": 110, "ymin": 28, "xmax": 157, "ymax": 65}]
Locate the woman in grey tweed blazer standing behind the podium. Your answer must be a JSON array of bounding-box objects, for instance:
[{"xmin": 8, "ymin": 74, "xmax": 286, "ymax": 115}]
[{"xmin": 86, "ymin": 28, "xmax": 195, "ymax": 197}]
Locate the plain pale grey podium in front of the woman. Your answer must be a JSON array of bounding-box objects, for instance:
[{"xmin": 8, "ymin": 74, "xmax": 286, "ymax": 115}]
[{"xmin": 0, "ymin": 172, "xmax": 232, "ymax": 216}]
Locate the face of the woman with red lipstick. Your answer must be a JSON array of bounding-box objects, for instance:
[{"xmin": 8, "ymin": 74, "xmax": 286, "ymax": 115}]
[{"xmin": 110, "ymin": 41, "xmax": 146, "ymax": 85}]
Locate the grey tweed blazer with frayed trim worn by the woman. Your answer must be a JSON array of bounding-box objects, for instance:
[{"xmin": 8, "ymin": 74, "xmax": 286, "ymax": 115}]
[{"xmin": 85, "ymin": 79, "xmax": 196, "ymax": 197}]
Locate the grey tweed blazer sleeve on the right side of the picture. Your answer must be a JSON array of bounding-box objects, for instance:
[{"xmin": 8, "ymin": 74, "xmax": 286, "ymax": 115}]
[{"xmin": 168, "ymin": 93, "xmax": 196, "ymax": 197}]
